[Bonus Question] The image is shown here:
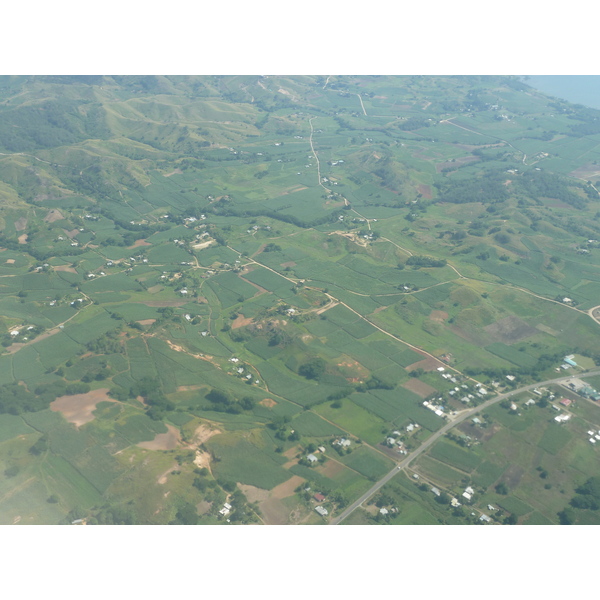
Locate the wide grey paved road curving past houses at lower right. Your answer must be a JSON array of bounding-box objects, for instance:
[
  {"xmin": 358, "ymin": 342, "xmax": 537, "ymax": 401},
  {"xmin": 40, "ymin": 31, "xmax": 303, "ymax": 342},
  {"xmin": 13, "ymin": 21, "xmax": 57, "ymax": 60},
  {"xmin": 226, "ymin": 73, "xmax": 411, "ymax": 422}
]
[{"xmin": 329, "ymin": 370, "xmax": 600, "ymax": 525}]
